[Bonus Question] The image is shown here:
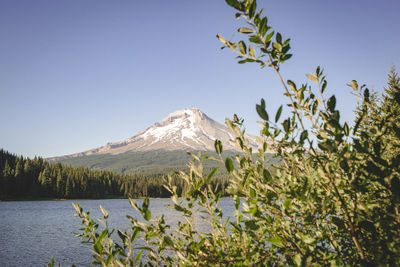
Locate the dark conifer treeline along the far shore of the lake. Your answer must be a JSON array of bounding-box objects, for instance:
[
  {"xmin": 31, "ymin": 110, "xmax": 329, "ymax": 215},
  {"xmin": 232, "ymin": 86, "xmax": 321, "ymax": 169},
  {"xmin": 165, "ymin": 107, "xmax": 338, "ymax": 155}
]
[{"xmin": 0, "ymin": 149, "xmax": 228, "ymax": 200}]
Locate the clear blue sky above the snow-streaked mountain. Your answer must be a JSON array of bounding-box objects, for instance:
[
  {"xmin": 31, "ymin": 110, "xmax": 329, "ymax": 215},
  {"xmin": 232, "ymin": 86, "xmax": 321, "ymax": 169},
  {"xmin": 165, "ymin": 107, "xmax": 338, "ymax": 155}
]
[{"xmin": 0, "ymin": 0, "xmax": 400, "ymax": 157}]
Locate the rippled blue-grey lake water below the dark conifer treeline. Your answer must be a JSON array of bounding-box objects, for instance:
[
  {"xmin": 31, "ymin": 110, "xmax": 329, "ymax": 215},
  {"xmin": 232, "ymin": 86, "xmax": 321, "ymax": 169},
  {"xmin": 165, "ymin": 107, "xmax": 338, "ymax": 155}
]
[{"xmin": 0, "ymin": 198, "xmax": 234, "ymax": 266}]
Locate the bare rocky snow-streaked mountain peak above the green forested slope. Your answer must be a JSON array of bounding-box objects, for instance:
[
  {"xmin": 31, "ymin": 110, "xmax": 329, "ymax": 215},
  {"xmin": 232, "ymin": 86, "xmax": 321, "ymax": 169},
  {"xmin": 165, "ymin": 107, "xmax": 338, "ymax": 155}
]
[{"xmin": 50, "ymin": 108, "xmax": 266, "ymax": 160}]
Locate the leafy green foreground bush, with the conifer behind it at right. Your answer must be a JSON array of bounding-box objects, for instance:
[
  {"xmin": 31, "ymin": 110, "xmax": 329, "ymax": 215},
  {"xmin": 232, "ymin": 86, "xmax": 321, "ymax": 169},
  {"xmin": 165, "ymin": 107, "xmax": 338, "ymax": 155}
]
[{"xmin": 64, "ymin": 0, "xmax": 400, "ymax": 266}]
